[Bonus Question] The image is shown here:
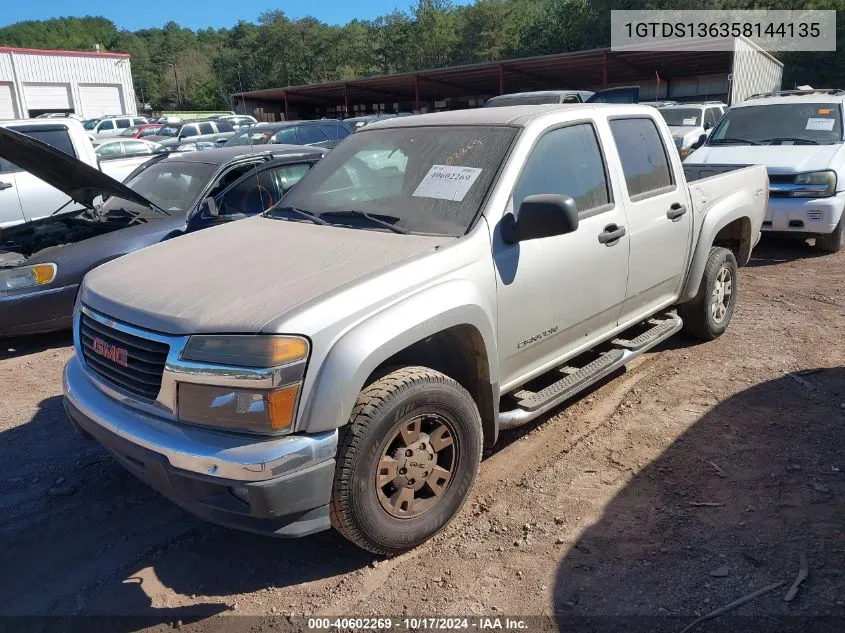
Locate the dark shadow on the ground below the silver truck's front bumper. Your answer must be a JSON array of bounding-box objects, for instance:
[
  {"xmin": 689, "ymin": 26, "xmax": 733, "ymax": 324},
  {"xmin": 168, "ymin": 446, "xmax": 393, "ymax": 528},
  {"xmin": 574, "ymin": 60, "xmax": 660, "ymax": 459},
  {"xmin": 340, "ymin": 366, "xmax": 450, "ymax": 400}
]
[{"xmin": 0, "ymin": 396, "xmax": 374, "ymax": 630}]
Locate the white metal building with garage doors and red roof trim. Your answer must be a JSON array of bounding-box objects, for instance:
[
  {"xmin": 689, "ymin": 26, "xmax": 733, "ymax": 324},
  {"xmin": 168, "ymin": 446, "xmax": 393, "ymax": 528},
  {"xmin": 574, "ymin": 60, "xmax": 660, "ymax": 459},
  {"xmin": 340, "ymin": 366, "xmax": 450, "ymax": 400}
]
[{"xmin": 0, "ymin": 46, "xmax": 137, "ymax": 119}]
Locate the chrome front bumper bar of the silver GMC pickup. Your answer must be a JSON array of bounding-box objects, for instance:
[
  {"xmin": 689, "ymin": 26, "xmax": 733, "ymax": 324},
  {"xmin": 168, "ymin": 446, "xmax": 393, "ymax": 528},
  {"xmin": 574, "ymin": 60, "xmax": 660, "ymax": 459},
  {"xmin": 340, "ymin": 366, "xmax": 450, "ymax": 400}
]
[{"xmin": 63, "ymin": 356, "xmax": 337, "ymax": 482}]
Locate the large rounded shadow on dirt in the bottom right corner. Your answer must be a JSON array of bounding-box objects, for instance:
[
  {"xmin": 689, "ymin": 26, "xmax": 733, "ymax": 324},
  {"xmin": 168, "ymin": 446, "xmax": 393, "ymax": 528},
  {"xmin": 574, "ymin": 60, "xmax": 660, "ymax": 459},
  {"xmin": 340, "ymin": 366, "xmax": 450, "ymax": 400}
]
[{"xmin": 554, "ymin": 368, "xmax": 845, "ymax": 633}]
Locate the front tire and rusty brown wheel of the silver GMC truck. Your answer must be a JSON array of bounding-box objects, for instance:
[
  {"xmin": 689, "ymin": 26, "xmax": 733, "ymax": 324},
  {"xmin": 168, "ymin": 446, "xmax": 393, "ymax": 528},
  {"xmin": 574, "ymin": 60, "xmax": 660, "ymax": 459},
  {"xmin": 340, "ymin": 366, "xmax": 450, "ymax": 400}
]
[{"xmin": 331, "ymin": 367, "xmax": 483, "ymax": 555}]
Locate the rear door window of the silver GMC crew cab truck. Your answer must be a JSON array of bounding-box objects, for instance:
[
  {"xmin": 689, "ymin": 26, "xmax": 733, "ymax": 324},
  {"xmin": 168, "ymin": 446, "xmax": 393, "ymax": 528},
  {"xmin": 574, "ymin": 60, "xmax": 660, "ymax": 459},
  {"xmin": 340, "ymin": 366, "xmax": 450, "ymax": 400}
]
[{"xmin": 610, "ymin": 118, "xmax": 674, "ymax": 199}]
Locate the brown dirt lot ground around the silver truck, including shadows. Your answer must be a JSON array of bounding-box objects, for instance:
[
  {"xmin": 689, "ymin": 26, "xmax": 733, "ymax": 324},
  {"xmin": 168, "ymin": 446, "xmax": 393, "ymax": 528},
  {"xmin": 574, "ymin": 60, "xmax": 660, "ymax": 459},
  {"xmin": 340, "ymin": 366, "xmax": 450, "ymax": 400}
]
[{"xmin": 0, "ymin": 241, "xmax": 845, "ymax": 632}]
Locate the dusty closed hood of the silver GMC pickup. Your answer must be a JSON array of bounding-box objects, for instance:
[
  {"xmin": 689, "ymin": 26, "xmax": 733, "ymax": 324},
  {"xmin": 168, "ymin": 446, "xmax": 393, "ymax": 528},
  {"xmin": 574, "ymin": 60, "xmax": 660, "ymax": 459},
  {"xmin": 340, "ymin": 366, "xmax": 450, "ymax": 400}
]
[{"xmin": 81, "ymin": 217, "xmax": 454, "ymax": 335}]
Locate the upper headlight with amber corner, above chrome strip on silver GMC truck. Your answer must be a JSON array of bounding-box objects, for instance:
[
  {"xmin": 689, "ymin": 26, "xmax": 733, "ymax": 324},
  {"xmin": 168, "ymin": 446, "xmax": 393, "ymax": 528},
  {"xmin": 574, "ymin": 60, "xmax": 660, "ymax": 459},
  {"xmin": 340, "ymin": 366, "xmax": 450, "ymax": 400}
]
[{"xmin": 182, "ymin": 334, "xmax": 308, "ymax": 367}]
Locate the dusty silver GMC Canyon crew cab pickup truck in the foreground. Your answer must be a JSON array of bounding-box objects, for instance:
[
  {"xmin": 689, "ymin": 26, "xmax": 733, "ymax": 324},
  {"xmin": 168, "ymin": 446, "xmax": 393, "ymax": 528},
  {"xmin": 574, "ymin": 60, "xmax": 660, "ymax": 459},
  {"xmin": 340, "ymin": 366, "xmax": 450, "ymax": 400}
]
[{"xmin": 64, "ymin": 104, "xmax": 767, "ymax": 554}]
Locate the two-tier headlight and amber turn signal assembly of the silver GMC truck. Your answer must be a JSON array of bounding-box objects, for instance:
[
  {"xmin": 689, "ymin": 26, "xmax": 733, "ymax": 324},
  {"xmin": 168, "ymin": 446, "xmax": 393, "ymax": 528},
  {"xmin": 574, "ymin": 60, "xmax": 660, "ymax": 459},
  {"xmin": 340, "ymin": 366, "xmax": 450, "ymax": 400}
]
[{"xmin": 178, "ymin": 335, "xmax": 309, "ymax": 434}]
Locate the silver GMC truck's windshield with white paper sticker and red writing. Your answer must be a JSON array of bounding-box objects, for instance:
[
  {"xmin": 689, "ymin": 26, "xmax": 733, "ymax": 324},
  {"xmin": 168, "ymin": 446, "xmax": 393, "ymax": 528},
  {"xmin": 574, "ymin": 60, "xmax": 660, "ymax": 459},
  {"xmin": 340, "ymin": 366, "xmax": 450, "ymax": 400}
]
[{"xmin": 268, "ymin": 126, "xmax": 516, "ymax": 236}]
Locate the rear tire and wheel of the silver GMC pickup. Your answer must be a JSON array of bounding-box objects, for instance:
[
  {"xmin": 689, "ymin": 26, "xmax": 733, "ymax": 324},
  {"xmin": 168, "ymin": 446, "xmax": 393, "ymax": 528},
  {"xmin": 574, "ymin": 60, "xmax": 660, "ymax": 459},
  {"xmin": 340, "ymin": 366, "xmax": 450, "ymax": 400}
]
[{"xmin": 678, "ymin": 247, "xmax": 739, "ymax": 341}]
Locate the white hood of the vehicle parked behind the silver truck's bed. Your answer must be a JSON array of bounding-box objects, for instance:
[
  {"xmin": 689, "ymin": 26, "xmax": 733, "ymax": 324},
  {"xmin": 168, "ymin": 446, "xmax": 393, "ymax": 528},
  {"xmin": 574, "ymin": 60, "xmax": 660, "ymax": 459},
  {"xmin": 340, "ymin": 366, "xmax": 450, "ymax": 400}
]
[{"xmin": 684, "ymin": 144, "xmax": 842, "ymax": 174}]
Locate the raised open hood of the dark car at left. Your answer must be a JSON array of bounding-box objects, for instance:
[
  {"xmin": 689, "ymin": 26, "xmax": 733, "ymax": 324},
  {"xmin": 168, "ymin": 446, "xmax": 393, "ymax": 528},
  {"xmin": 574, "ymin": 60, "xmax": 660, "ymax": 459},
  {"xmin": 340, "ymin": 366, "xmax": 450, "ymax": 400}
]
[{"xmin": 0, "ymin": 127, "xmax": 154, "ymax": 209}]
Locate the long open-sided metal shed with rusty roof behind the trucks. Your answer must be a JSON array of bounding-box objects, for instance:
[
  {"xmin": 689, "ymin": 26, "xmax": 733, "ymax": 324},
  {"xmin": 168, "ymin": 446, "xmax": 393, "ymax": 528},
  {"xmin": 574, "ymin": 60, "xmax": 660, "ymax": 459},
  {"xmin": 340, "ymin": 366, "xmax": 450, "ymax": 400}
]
[{"xmin": 233, "ymin": 38, "xmax": 783, "ymax": 121}]
